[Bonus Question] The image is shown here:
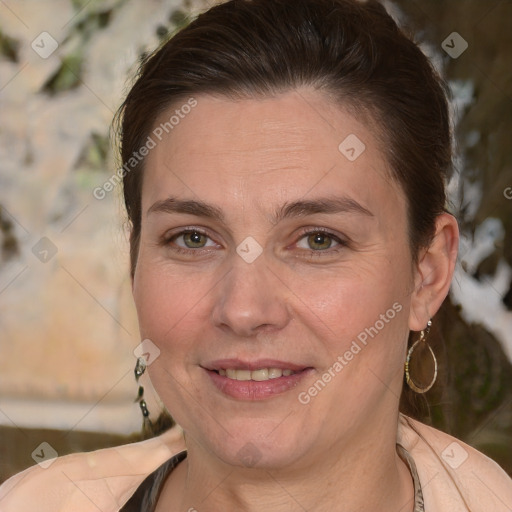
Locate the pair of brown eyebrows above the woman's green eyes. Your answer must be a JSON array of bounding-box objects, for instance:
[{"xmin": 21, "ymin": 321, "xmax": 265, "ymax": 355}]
[{"xmin": 146, "ymin": 196, "xmax": 374, "ymax": 224}]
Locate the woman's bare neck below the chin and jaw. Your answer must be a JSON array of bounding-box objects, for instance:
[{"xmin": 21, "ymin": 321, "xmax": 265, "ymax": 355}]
[{"xmin": 157, "ymin": 414, "xmax": 414, "ymax": 512}]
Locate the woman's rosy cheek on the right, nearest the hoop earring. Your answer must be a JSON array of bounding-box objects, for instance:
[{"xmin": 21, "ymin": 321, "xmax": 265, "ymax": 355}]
[{"xmin": 302, "ymin": 255, "xmax": 409, "ymax": 380}]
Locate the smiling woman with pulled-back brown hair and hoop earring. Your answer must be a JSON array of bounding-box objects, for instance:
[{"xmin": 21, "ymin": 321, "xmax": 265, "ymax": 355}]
[{"xmin": 0, "ymin": 0, "xmax": 512, "ymax": 512}]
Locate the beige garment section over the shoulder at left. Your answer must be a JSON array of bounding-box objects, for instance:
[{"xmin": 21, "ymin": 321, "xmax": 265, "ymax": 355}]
[{"xmin": 0, "ymin": 427, "xmax": 185, "ymax": 512}]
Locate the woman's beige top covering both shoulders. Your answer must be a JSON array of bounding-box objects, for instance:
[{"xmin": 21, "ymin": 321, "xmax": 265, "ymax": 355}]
[{"xmin": 0, "ymin": 415, "xmax": 512, "ymax": 512}]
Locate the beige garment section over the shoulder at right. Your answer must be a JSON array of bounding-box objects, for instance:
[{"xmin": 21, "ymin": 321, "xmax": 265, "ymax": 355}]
[{"xmin": 397, "ymin": 415, "xmax": 512, "ymax": 512}]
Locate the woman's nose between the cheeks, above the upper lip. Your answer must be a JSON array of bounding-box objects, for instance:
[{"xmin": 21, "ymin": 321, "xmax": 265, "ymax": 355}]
[{"xmin": 212, "ymin": 255, "xmax": 290, "ymax": 338}]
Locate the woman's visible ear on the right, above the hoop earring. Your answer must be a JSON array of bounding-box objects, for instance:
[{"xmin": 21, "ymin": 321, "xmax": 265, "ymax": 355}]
[{"xmin": 409, "ymin": 213, "xmax": 459, "ymax": 331}]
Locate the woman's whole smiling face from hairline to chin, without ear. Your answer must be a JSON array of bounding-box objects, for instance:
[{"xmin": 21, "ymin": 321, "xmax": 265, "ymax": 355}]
[{"xmin": 133, "ymin": 89, "xmax": 414, "ymax": 467}]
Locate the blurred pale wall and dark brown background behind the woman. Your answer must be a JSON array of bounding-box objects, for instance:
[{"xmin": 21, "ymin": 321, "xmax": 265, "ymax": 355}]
[{"xmin": 0, "ymin": 0, "xmax": 512, "ymax": 482}]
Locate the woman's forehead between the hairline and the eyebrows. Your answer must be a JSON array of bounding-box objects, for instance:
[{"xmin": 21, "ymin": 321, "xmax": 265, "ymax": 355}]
[{"xmin": 142, "ymin": 89, "xmax": 401, "ymax": 220}]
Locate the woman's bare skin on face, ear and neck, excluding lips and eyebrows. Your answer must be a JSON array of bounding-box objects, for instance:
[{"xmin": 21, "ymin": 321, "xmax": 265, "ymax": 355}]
[{"xmin": 133, "ymin": 88, "xmax": 458, "ymax": 512}]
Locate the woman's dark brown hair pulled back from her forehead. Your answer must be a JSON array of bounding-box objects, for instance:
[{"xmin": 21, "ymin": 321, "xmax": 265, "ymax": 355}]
[{"xmin": 117, "ymin": 0, "xmax": 452, "ymax": 430}]
